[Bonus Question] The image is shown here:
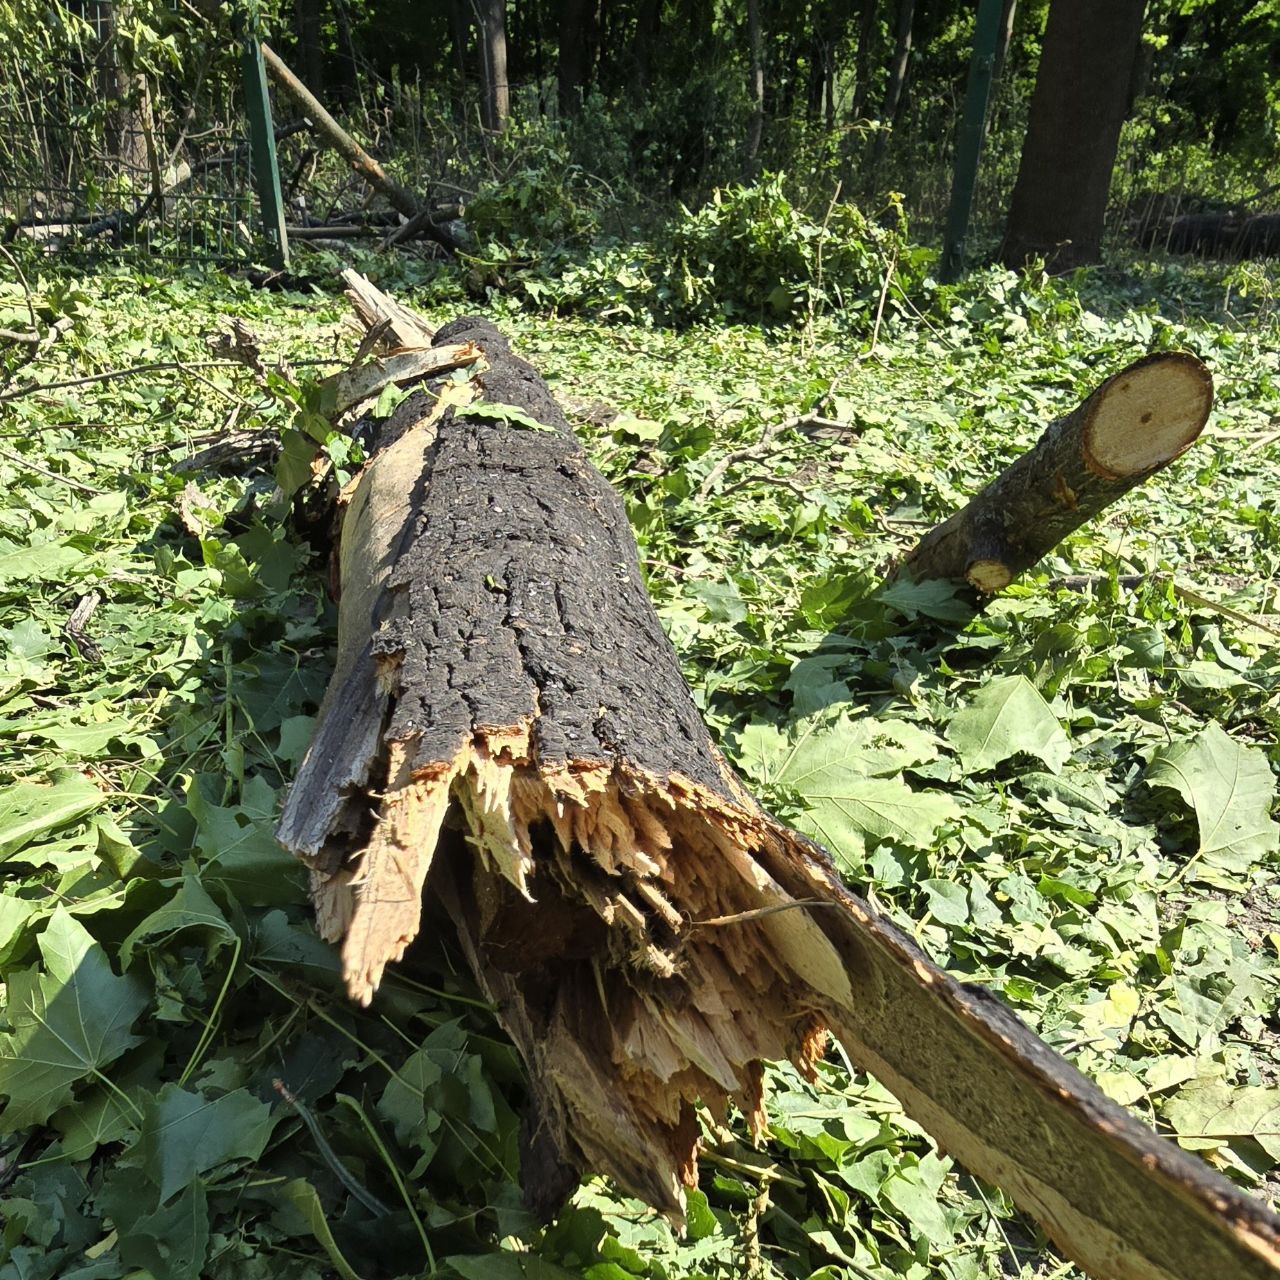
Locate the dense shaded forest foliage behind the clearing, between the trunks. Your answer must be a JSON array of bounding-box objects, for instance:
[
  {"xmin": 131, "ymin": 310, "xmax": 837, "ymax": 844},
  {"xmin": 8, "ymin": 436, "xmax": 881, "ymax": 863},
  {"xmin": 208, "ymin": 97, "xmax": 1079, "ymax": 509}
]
[{"xmin": 0, "ymin": 0, "xmax": 1280, "ymax": 251}]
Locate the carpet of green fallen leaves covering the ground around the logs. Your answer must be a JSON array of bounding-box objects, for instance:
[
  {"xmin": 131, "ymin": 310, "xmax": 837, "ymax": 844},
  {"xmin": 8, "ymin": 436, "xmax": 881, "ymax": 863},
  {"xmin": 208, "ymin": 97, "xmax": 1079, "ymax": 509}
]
[{"xmin": 0, "ymin": 249, "xmax": 1280, "ymax": 1280}]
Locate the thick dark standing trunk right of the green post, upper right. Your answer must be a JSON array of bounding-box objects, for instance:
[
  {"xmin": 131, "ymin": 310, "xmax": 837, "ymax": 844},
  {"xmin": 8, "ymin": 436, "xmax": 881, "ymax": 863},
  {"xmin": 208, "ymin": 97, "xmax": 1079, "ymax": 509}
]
[{"xmin": 1000, "ymin": 0, "xmax": 1144, "ymax": 271}]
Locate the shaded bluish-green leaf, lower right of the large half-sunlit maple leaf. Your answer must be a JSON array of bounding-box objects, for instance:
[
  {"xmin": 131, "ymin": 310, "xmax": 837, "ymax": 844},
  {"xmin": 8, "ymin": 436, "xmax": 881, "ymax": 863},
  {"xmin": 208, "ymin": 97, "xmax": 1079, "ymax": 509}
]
[{"xmin": 138, "ymin": 1084, "xmax": 275, "ymax": 1204}]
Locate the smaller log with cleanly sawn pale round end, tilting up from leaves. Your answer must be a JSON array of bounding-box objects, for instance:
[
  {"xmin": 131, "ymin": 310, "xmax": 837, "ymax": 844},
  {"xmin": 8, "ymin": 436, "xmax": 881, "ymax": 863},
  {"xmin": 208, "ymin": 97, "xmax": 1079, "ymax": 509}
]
[{"xmin": 893, "ymin": 351, "xmax": 1213, "ymax": 608}]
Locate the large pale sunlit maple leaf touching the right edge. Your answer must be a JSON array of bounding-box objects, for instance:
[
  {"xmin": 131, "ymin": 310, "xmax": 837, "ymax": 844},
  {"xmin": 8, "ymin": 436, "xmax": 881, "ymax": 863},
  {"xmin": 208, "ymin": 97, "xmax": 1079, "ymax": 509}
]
[{"xmin": 1146, "ymin": 724, "xmax": 1280, "ymax": 872}]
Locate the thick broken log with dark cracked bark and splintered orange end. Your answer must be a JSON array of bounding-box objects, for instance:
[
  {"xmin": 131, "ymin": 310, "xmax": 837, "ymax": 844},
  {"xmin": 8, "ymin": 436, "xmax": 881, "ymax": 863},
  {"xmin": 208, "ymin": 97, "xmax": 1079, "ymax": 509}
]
[{"xmin": 279, "ymin": 319, "xmax": 1280, "ymax": 1280}]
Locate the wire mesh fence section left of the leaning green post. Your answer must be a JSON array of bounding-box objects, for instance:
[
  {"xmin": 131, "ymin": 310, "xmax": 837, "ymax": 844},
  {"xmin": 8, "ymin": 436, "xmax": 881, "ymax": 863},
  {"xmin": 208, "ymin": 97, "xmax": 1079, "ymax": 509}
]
[{"xmin": 0, "ymin": 0, "xmax": 257, "ymax": 261}]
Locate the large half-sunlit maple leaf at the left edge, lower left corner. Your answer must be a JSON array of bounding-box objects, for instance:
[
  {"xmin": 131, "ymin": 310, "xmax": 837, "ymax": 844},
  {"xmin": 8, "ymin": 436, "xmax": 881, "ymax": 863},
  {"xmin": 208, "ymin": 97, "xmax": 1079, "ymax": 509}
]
[{"xmin": 0, "ymin": 908, "xmax": 148, "ymax": 1132}]
